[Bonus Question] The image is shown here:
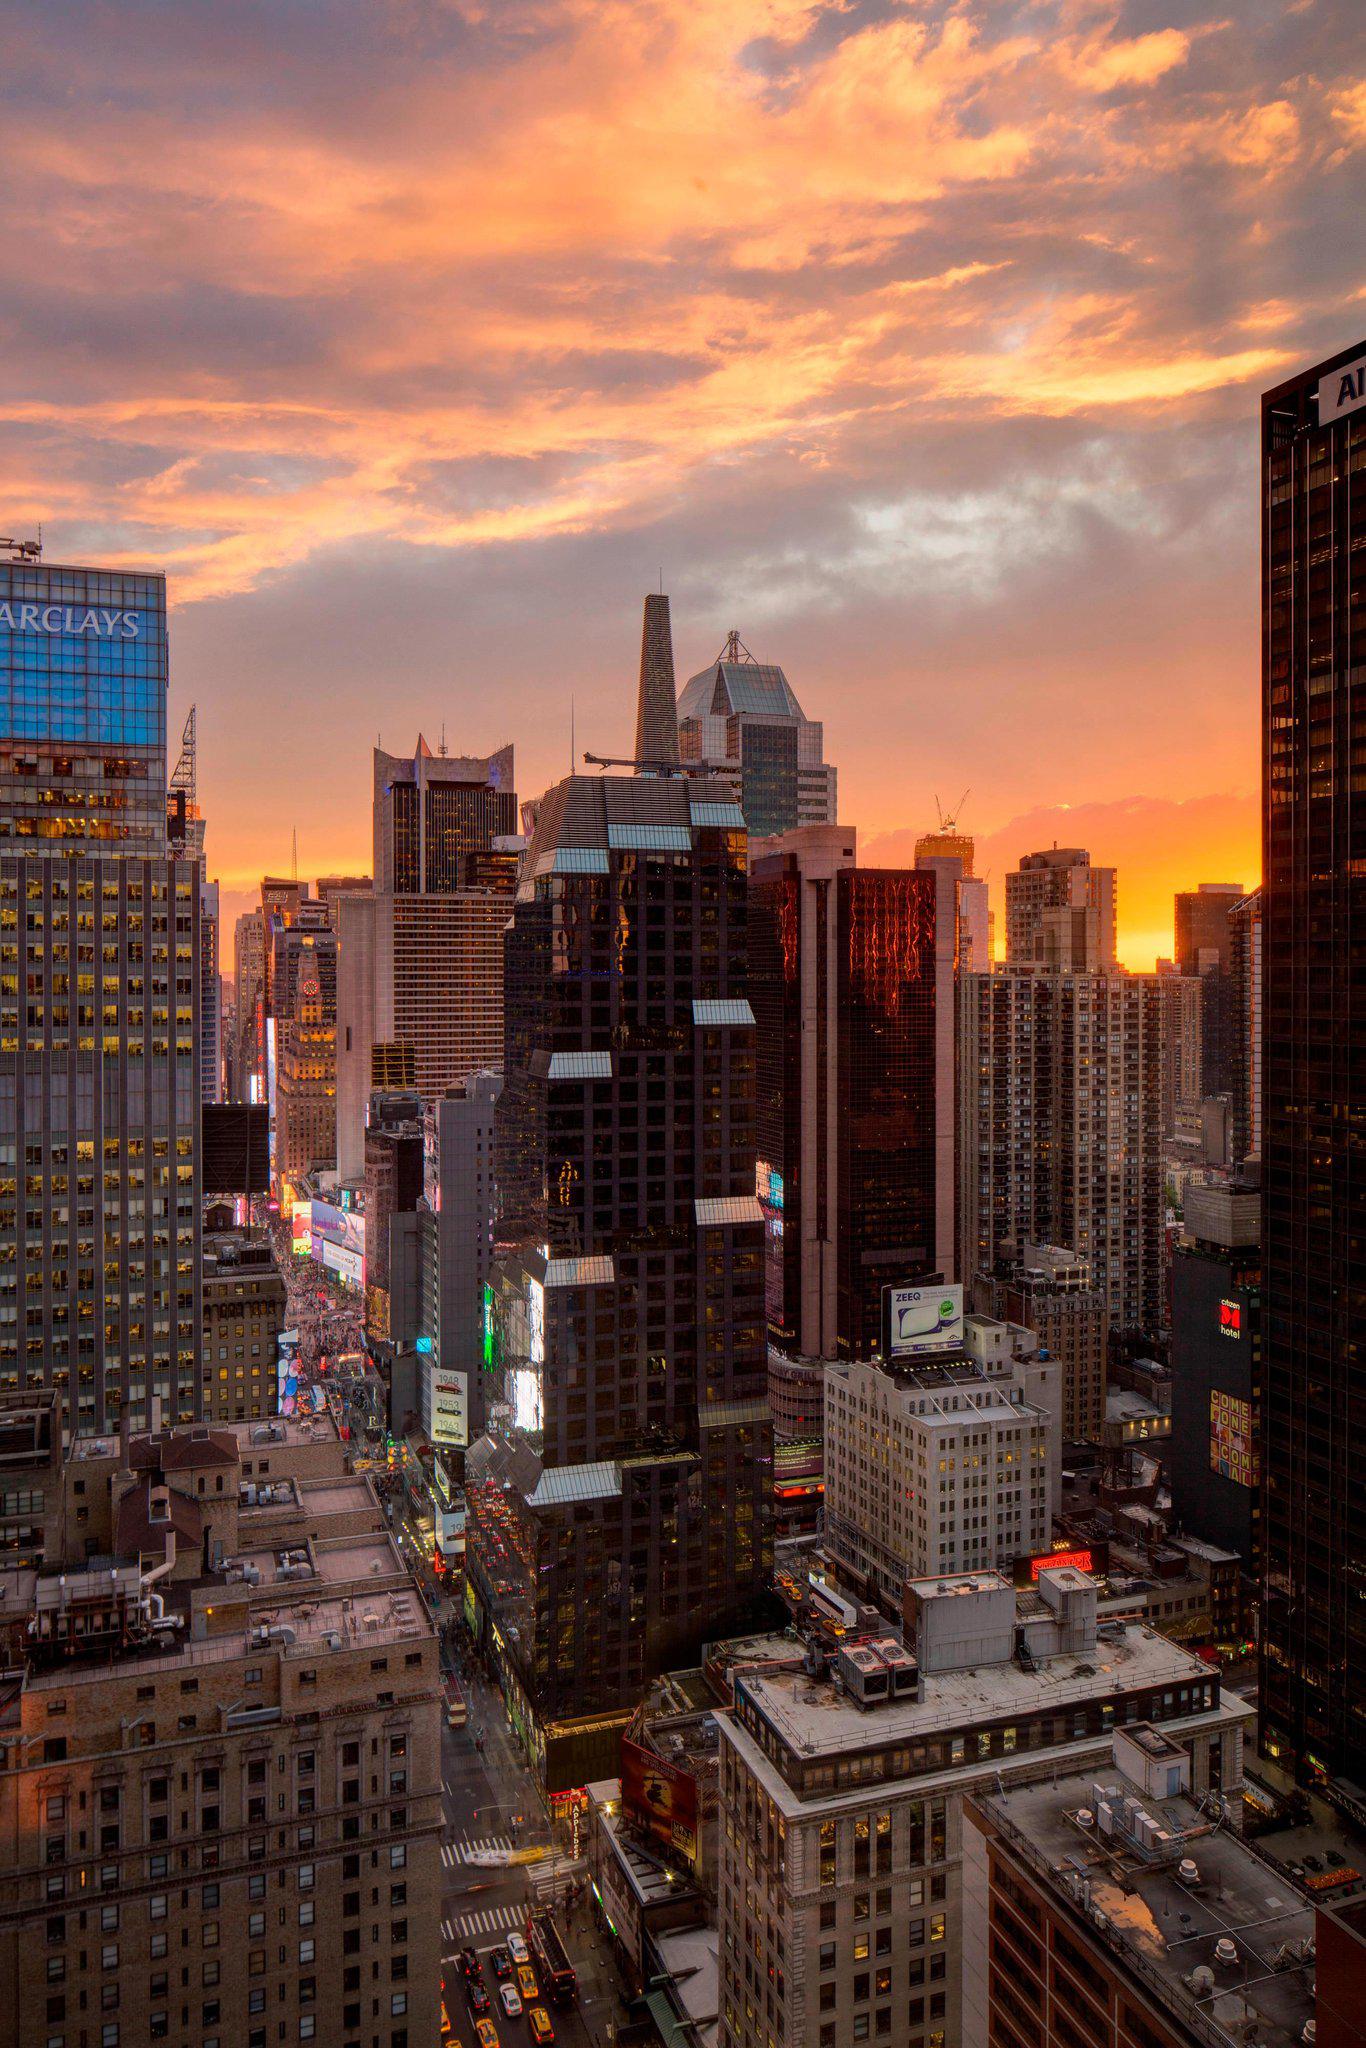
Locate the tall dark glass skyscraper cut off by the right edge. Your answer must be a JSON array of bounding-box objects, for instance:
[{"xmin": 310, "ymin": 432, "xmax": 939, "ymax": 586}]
[{"xmin": 1262, "ymin": 344, "xmax": 1366, "ymax": 1784}]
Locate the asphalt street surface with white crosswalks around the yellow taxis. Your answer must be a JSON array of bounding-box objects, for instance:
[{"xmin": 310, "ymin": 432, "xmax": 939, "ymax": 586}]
[{"xmin": 440, "ymin": 1646, "xmax": 625, "ymax": 2048}]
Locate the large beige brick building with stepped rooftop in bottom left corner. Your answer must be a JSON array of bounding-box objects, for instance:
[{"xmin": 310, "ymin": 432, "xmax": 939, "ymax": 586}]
[{"xmin": 0, "ymin": 1425, "xmax": 442, "ymax": 2048}]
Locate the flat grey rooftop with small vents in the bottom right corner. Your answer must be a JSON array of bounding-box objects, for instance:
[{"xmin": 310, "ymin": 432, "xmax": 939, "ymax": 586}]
[{"xmin": 977, "ymin": 1772, "xmax": 1315, "ymax": 2048}]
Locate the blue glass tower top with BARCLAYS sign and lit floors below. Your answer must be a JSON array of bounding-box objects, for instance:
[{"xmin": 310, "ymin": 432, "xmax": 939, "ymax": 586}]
[{"xmin": 0, "ymin": 561, "xmax": 166, "ymax": 852}]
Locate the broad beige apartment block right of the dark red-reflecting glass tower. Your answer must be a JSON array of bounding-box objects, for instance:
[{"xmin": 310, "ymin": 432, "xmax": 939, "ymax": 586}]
[{"xmin": 958, "ymin": 967, "xmax": 1165, "ymax": 1331}]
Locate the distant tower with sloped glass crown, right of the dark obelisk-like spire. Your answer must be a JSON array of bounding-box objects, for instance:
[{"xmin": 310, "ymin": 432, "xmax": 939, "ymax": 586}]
[{"xmin": 678, "ymin": 633, "xmax": 836, "ymax": 840}]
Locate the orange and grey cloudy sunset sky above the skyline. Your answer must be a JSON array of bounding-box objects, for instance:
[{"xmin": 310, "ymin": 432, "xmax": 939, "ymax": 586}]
[{"xmin": 0, "ymin": 0, "xmax": 1366, "ymax": 967}]
